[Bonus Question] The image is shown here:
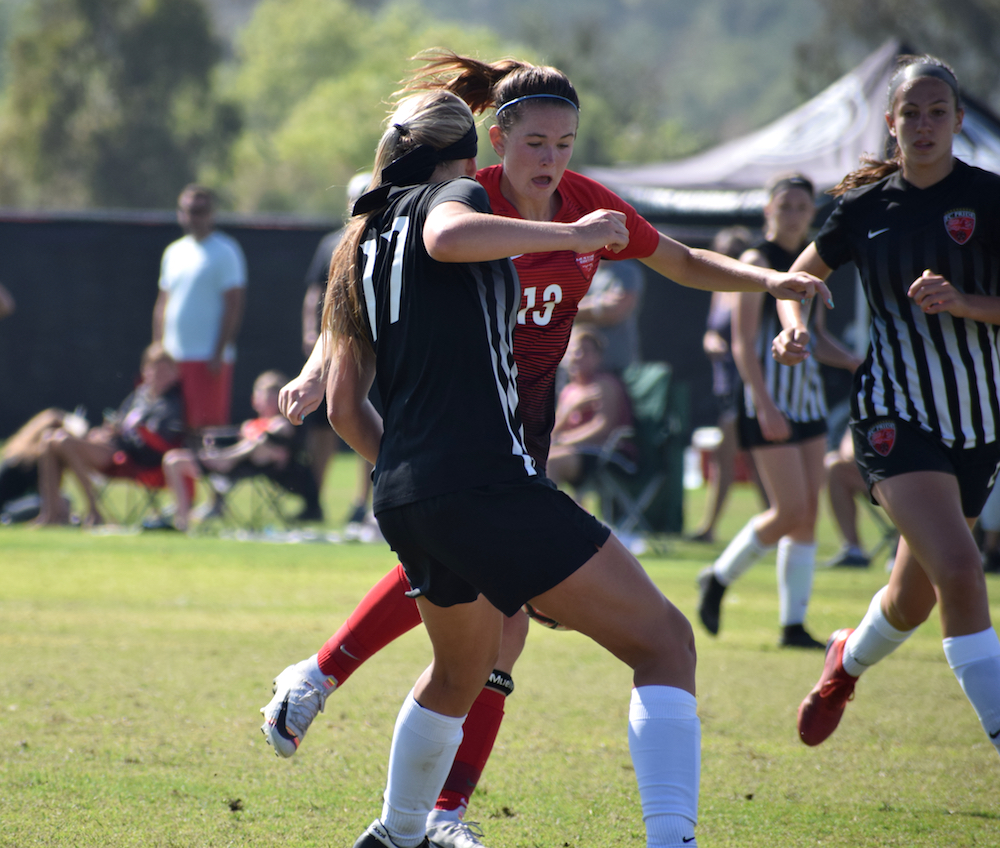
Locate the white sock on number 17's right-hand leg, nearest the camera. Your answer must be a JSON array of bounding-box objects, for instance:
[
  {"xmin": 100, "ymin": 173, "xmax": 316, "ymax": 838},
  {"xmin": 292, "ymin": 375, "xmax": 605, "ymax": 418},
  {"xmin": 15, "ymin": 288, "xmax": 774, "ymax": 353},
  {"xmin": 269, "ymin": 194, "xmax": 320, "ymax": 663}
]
[{"xmin": 628, "ymin": 686, "xmax": 701, "ymax": 848}]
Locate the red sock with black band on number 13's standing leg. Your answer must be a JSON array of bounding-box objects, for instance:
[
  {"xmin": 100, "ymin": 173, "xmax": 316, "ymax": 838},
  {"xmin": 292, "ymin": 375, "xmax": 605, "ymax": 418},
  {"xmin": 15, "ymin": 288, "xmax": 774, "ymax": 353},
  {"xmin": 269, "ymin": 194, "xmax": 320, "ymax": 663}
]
[{"xmin": 434, "ymin": 671, "xmax": 514, "ymax": 812}]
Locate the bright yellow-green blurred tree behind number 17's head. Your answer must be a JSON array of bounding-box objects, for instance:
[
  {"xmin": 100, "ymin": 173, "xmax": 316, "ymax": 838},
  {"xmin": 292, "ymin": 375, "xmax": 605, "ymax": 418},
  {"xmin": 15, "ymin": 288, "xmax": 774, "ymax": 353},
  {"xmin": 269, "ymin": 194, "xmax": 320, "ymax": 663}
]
[{"xmin": 225, "ymin": 0, "xmax": 525, "ymax": 217}]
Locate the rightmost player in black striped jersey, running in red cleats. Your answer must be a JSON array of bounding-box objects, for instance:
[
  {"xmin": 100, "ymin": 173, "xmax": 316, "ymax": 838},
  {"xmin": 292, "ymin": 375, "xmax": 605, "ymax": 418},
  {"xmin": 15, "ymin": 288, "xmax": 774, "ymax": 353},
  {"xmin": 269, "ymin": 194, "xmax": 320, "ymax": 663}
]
[{"xmin": 773, "ymin": 56, "xmax": 1000, "ymax": 760}]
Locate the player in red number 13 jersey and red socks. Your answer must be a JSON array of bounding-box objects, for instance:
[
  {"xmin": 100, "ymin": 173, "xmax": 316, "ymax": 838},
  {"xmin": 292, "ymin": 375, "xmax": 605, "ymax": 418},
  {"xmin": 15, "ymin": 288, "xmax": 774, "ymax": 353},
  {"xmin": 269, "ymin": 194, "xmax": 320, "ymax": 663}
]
[{"xmin": 270, "ymin": 54, "xmax": 829, "ymax": 848}]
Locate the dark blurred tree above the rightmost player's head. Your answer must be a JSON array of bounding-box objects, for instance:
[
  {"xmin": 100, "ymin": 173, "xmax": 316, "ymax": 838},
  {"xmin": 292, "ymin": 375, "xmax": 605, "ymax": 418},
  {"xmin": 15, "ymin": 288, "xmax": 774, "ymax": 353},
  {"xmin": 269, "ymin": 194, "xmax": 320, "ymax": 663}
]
[{"xmin": 798, "ymin": 0, "xmax": 1000, "ymax": 110}]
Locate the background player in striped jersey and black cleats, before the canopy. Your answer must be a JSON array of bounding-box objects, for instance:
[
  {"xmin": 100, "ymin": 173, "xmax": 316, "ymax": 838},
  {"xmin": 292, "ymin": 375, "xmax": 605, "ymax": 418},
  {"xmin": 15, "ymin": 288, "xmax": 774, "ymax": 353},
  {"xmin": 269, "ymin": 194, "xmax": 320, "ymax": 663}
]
[{"xmin": 698, "ymin": 174, "xmax": 858, "ymax": 648}]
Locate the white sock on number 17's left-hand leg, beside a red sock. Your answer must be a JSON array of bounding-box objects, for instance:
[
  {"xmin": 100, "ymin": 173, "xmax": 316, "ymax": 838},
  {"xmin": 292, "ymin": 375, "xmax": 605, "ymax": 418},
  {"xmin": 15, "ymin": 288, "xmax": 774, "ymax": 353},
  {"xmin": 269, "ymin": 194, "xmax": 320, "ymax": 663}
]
[{"xmin": 382, "ymin": 691, "xmax": 465, "ymax": 848}]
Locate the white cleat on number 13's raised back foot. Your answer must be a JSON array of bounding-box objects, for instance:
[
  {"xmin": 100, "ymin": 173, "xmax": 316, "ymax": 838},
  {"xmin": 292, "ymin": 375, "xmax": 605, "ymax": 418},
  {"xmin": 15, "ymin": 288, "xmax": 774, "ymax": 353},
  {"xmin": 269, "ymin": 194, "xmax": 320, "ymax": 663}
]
[{"xmin": 260, "ymin": 655, "xmax": 337, "ymax": 757}]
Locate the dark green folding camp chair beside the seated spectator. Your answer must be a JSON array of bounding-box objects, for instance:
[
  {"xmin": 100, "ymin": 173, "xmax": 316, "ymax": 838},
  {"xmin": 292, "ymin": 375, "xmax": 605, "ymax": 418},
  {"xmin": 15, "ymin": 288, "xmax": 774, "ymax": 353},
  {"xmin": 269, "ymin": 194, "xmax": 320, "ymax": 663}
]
[{"xmin": 588, "ymin": 362, "xmax": 687, "ymax": 548}]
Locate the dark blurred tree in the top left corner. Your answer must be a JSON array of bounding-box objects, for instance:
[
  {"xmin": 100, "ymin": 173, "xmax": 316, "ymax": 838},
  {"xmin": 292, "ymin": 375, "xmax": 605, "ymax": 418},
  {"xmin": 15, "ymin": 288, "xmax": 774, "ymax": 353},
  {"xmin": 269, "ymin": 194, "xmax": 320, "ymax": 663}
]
[{"xmin": 0, "ymin": 0, "xmax": 240, "ymax": 208}]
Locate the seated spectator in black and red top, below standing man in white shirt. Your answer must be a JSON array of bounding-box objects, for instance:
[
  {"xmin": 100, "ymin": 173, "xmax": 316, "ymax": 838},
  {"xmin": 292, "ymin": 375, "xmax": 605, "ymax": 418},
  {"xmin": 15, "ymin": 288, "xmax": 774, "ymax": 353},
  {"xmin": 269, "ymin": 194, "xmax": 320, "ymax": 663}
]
[{"xmin": 36, "ymin": 342, "xmax": 185, "ymax": 526}]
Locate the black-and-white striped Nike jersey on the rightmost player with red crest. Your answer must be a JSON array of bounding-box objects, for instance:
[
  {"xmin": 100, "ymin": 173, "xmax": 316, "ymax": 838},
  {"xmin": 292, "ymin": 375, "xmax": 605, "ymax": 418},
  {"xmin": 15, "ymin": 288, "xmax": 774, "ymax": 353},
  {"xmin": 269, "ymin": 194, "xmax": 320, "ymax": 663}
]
[{"xmin": 816, "ymin": 160, "xmax": 1000, "ymax": 448}]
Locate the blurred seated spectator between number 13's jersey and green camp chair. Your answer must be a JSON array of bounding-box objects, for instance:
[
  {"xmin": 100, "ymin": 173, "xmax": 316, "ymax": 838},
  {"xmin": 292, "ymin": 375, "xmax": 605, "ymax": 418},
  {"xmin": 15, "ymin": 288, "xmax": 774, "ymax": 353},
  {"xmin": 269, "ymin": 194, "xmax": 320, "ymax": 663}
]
[{"xmin": 546, "ymin": 325, "xmax": 633, "ymax": 496}]
